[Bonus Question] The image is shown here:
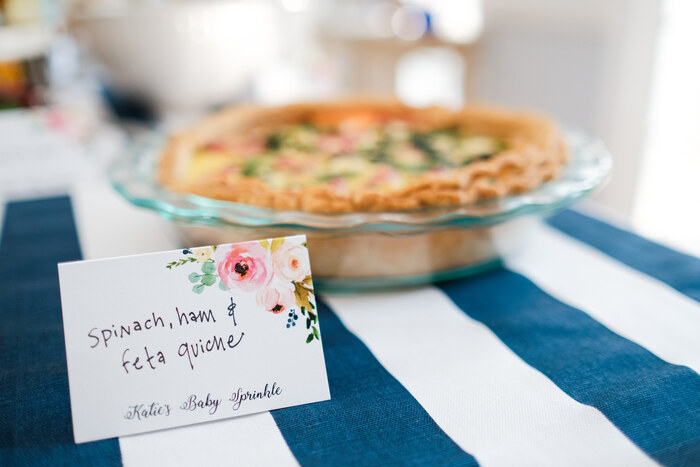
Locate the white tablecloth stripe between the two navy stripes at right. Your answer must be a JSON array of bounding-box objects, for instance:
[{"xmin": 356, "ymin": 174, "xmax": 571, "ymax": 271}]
[{"xmin": 506, "ymin": 224, "xmax": 700, "ymax": 372}]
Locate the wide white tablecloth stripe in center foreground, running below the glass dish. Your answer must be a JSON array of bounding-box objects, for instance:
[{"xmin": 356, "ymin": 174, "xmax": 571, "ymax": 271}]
[{"xmin": 326, "ymin": 288, "xmax": 655, "ymax": 466}]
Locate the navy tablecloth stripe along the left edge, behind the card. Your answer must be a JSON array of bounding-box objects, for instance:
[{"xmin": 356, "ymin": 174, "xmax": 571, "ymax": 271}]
[{"xmin": 0, "ymin": 197, "xmax": 121, "ymax": 466}]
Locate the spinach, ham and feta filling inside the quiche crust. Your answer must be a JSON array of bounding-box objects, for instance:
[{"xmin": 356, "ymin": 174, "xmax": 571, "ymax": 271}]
[{"xmin": 187, "ymin": 120, "xmax": 507, "ymax": 193}]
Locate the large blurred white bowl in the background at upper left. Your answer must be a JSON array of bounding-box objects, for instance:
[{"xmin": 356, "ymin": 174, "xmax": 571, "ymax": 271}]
[{"xmin": 72, "ymin": 0, "xmax": 280, "ymax": 113}]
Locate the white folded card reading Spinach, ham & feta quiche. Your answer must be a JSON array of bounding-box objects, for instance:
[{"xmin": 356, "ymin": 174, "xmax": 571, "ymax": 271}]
[{"xmin": 58, "ymin": 236, "xmax": 330, "ymax": 443}]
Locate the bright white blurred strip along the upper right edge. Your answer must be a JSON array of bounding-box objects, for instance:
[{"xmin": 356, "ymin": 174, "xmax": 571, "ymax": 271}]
[{"xmin": 632, "ymin": 0, "xmax": 700, "ymax": 255}]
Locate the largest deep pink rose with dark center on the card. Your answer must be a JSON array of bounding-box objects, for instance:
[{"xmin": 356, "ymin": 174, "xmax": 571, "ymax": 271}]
[{"xmin": 218, "ymin": 242, "xmax": 272, "ymax": 292}]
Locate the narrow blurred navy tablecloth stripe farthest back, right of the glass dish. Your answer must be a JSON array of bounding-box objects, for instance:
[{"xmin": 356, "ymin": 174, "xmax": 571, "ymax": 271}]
[{"xmin": 547, "ymin": 209, "xmax": 700, "ymax": 301}]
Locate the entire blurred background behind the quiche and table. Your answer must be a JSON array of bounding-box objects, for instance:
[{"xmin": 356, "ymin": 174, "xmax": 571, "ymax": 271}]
[{"xmin": 0, "ymin": 0, "xmax": 700, "ymax": 254}]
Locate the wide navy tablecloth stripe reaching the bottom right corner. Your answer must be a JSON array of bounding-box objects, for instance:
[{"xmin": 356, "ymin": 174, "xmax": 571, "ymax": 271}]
[{"xmin": 438, "ymin": 269, "xmax": 700, "ymax": 465}]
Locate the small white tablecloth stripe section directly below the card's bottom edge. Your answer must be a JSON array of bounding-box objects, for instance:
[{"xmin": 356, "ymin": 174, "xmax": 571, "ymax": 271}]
[{"xmin": 119, "ymin": 412, "xmax": 298, "ymax": 467}]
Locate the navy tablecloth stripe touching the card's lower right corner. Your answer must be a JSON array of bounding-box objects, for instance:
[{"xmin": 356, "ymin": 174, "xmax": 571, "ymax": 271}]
[{"xmin": 272, "ymin": 300, "xmax": 477, "ymax": 466}]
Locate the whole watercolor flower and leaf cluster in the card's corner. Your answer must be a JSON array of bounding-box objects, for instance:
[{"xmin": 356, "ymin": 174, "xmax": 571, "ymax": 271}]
[{"xmin": 165, "ymin": 238, "xmax": 321, "ymax": 343}]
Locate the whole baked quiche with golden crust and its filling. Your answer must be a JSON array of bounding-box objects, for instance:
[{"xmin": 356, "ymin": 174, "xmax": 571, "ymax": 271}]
[{"xmin": 158, "ymin": 100, "xmax": 566, "ymax": 213}]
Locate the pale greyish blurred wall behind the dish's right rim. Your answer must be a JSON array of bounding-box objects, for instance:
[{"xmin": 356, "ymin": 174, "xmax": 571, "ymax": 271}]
[{"xmin": 468, "ymin": 0, "xmax": 660, "ymax": 215}]
